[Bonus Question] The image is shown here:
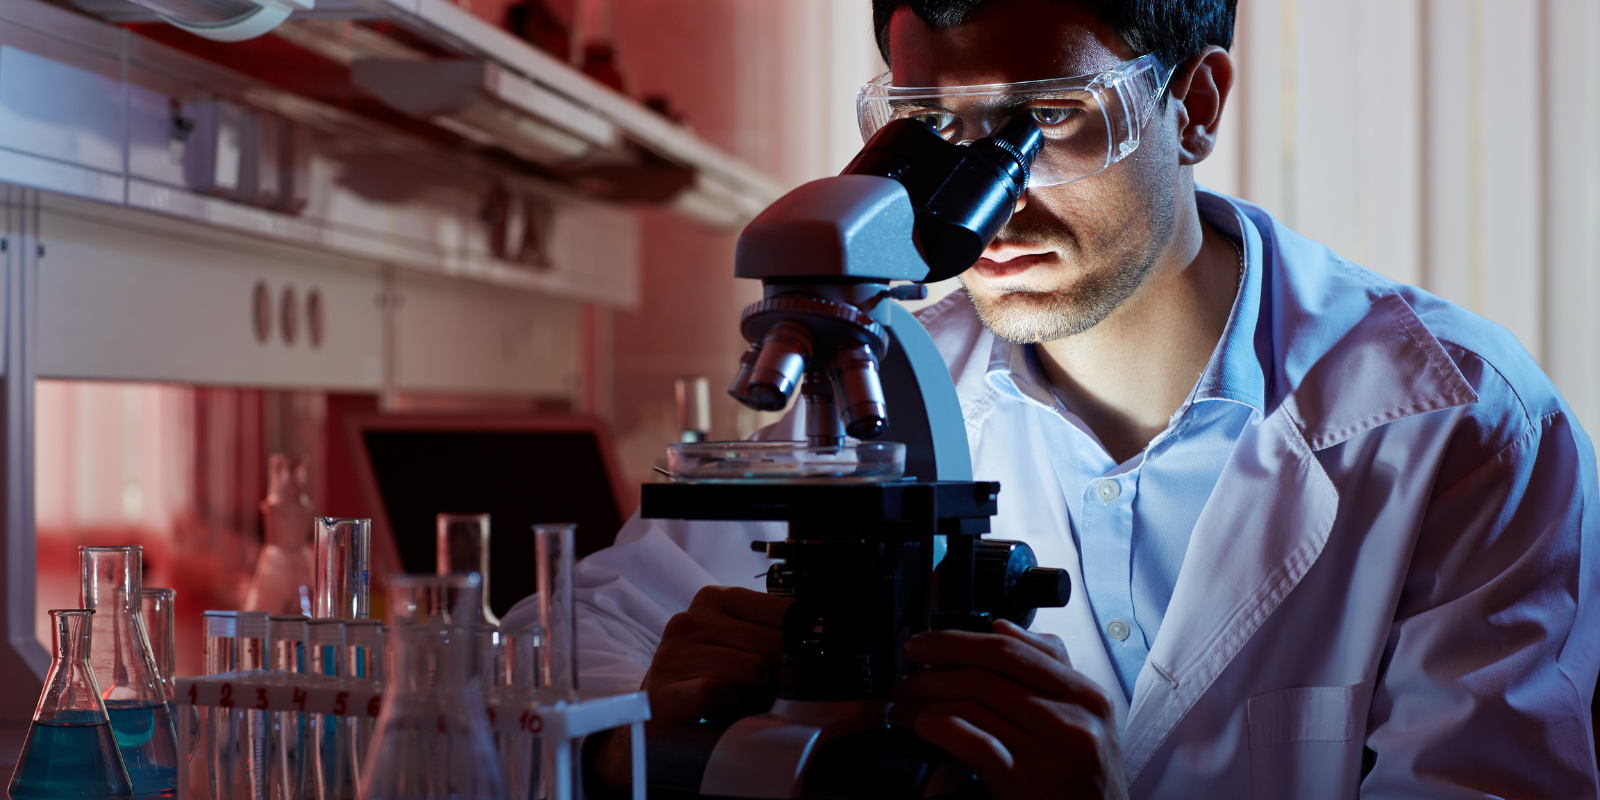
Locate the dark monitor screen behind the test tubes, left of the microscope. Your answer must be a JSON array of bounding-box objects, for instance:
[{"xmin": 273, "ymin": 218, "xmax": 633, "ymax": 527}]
[{"xmin": 352, "ymin": 414, "xmax": 626, "ymax": 614}]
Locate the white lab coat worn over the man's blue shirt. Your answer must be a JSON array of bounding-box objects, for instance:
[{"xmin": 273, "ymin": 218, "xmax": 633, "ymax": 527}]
[{"xmin": 508, "ymin": 192, "xmax": 1600, "ymax": 798}]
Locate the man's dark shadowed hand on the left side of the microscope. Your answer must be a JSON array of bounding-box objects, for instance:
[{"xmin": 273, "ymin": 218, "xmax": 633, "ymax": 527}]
[{"xmin": 595, "ymin": 586, "xmax": 794, "ymax": 790}]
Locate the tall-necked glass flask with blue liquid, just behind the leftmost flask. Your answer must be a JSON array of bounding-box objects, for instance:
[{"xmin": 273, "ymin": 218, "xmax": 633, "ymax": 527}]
[{"xmin": 78, "ymin": 546, "xmax": 178, "ymax": 797}]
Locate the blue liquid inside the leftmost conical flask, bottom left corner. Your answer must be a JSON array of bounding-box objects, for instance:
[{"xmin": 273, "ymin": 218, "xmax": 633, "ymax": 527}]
[{"xmin": 11, "ymin": 712, "xmax": 133, "ymax": 798}]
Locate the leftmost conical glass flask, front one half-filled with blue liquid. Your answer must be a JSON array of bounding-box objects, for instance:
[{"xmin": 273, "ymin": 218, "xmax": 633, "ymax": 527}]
[{"xmin": 10, "ymin": 610, "xmax": 133, "ymax": 798}]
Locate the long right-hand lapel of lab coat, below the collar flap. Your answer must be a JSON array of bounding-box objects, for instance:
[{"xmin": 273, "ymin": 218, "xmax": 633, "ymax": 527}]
[{"xmin": 1122, "ymin": 398, "xmax": 1339, "ymax": 782}]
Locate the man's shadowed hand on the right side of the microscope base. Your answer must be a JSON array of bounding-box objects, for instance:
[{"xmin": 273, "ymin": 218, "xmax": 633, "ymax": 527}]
[{"xmin": 890, "ymin": 621, "xmax": 1128, "ymax": 800}]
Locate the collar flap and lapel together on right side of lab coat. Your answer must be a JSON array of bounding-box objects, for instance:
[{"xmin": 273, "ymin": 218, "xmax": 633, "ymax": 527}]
[{"xmin": 1122, "ymin": 274, "xmax": 1477, "ymax": 782}]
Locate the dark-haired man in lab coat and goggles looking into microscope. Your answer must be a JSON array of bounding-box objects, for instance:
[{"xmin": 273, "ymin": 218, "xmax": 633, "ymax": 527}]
[{"xmin": 508, "ymin": 0, "xmax": 1600, "ymax": 798}]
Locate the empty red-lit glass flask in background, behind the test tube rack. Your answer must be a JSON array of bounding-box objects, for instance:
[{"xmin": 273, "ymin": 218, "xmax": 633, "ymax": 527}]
[{"xmin": 245, "ymin": 453, "xmax": 315, "ymax": 616}]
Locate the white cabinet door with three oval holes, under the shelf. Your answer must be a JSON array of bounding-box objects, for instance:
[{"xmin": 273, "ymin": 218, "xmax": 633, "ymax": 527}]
[{"xmin": 37, "ymin": 197, "xmax": 382, "ymax": 392}]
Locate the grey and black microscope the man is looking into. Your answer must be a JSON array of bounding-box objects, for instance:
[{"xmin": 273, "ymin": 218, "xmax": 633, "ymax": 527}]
[{"xmin": 640, "ymin": 115, "xmax": 1070, "ymax": 798}]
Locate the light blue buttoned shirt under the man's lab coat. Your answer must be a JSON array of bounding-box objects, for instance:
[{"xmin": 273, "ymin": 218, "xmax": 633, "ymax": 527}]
[{"xmin": 987, "ymin": 206, "xmax": 1266, "ymax": 698}]
